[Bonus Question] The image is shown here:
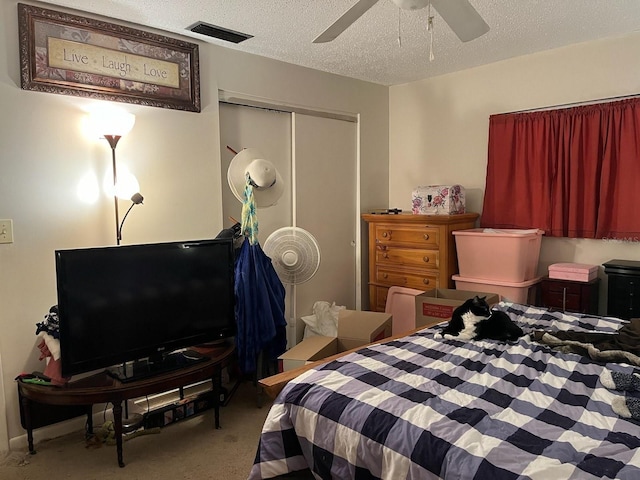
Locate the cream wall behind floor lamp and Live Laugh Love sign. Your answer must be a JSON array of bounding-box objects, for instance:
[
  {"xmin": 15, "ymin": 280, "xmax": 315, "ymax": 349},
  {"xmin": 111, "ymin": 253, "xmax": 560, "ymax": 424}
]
[{"xmin": 0, "ymin": 0, "xmax": 388, "ymax": 451}]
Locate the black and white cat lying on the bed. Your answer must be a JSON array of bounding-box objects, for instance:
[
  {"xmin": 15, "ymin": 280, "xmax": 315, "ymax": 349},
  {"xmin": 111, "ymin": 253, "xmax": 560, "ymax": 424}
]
[{"xmin": 442, "ymin": 295, "xmax": 524, "ymax": 342}]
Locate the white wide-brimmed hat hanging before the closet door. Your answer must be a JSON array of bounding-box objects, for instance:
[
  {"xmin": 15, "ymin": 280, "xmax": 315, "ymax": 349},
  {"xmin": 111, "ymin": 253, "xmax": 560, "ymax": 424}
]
[{"xmin": 227, "ymin": 148, "xmax": 284, "ymax": 208}]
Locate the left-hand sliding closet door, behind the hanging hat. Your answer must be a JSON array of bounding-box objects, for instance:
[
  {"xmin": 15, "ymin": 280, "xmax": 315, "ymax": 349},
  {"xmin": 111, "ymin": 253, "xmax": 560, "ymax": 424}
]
[{"xmin": 220, "ymin": 103, "xmax": 292, "ymax": 238}]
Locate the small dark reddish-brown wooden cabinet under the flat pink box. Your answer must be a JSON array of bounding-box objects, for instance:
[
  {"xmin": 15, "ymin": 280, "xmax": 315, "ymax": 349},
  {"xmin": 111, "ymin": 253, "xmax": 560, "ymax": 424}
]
[{"xmin": 540, "ymin": 277, "xmax": 600, "ymax": 315}]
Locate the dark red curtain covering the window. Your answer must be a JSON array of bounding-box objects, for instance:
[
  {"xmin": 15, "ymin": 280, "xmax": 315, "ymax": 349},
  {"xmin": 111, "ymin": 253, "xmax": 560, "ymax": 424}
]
[{"xmin": 481, "ymin": 99, "xmax": 640, "ymax": 241}]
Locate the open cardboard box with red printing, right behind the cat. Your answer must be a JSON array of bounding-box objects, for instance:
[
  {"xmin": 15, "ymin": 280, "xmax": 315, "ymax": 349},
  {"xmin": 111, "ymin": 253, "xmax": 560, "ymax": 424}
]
[{"xmin": 416, "ymin": 288, "xmax": 500, "ymax": 327}]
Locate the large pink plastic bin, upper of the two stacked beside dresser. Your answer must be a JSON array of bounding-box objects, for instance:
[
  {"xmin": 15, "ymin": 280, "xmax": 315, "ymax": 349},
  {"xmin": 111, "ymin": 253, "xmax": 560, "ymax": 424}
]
[{"xmin": 453, "ymin": 228, "xmax": 544, "ymax": 282}]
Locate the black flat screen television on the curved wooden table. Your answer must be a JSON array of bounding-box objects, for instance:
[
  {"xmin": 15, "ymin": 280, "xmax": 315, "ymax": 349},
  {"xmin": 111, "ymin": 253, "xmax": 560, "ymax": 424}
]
[{"xmin": 55, "ymin": 238, "xmax": 236, "ymax": 381}]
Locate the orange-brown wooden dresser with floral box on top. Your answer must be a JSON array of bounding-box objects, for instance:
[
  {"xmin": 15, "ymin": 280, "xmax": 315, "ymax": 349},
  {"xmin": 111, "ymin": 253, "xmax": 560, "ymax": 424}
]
[{"xmin": 362, "ymin": 213, "xmax": 478, "ymax": 312}]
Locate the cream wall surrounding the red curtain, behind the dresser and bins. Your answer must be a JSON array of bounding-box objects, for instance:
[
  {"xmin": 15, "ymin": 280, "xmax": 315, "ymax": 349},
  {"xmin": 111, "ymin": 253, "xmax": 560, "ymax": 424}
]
[{"xmin": 389, "ymin": 34, "xmax": 640, "ymax": 313}]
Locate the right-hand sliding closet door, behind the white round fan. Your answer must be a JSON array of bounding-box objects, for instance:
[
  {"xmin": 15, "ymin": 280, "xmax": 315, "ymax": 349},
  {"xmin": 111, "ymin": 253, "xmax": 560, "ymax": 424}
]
[{"xmin": 293, "ymin": 114, "xmax": 358, "ymax": 328}]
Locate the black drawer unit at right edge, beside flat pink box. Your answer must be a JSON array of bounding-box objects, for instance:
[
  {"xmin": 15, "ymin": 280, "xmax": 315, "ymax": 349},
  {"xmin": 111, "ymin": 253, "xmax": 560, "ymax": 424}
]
[{"xmin": 603, "ymin": 260, "xmax": 640, "ymax": 320}]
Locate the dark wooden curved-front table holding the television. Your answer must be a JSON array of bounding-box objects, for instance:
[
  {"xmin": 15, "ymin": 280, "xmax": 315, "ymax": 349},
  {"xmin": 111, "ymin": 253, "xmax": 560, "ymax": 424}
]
[{"xmin": 18, "ymin": 343, "xmax": 235, "ymax": 467}]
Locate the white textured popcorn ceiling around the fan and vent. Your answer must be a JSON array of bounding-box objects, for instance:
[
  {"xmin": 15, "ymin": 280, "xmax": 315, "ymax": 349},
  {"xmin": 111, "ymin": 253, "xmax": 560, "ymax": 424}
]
[{"xmin": 35, "ymin": 0, "xmax": 640, "ymax": 85}]
